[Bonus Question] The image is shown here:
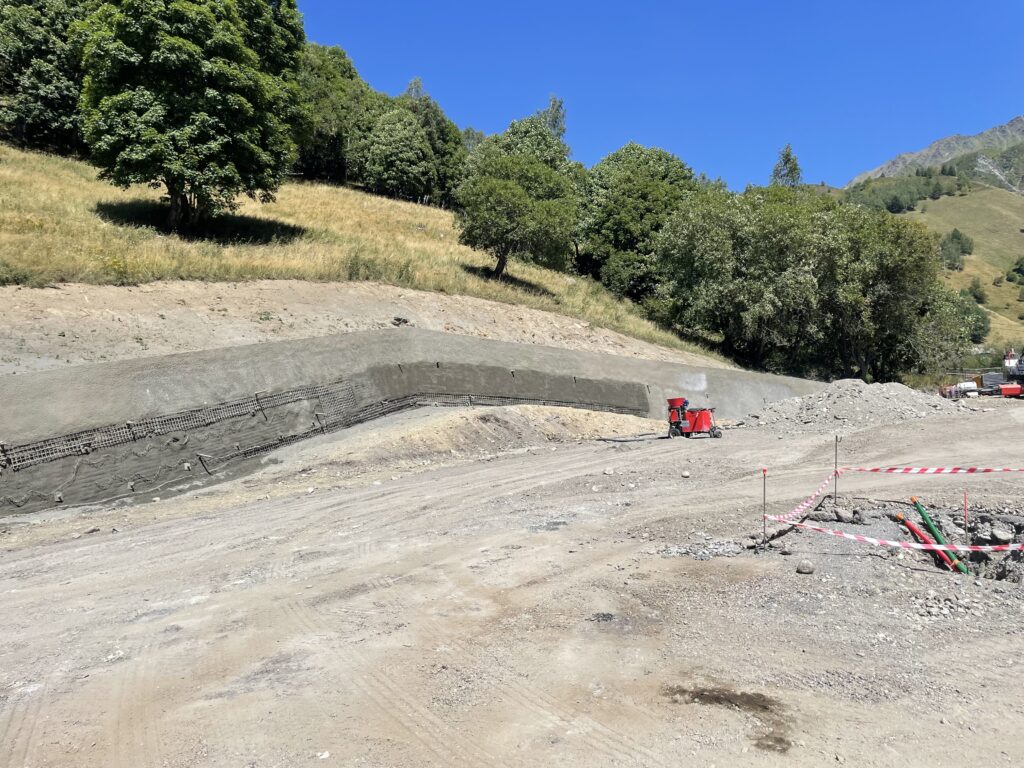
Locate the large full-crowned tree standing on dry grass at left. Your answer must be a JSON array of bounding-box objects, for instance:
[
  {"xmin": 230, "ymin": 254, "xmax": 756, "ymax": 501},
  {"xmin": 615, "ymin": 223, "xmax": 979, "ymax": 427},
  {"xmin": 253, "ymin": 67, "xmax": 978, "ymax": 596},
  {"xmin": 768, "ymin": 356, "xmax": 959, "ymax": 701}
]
[{"xmin": 81, "ymin": 0, "xmax": 297, "ymax": 226}]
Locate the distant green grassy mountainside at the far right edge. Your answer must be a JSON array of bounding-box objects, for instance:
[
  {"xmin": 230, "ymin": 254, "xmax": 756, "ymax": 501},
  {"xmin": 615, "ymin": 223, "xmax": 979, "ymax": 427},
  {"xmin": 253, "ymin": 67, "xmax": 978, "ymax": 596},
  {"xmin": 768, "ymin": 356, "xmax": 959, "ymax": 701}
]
[{"xmin": 902, "ymin": 186, "xmax": 1024, "ymax": 342}]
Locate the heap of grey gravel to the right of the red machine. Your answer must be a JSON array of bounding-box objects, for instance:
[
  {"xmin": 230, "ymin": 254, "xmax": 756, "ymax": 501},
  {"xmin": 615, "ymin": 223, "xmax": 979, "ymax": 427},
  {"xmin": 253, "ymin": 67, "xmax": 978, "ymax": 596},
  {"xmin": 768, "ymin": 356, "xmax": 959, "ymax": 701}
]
[{"xmin": 748, "ymin": 379, "xmax": 966, "ymax": 434}]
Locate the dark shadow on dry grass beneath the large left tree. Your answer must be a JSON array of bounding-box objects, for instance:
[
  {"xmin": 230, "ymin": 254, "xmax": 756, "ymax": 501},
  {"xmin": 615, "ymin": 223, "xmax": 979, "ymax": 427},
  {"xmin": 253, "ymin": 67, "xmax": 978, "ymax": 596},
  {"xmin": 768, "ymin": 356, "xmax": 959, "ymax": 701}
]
[{"xmin": 96, "ymin": 200, "xmax": 307, "ymax": 246}]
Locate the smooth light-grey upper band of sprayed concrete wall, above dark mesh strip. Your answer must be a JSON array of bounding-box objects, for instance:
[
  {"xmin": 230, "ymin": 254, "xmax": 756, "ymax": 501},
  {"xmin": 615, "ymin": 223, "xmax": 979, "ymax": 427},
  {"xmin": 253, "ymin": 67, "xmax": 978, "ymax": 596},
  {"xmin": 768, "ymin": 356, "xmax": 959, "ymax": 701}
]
[{"xmin": 0, "ymin": 328, "xmax": 821, "ymax": 443}]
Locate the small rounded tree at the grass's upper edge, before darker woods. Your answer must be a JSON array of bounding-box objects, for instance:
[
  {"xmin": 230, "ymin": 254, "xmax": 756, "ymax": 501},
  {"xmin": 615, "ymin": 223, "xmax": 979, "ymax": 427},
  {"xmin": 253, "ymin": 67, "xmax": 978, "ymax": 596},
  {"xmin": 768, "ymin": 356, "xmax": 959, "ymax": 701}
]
[{"xmin": 366, "ymin": 109, "xmax": 437, "ymax": 200}]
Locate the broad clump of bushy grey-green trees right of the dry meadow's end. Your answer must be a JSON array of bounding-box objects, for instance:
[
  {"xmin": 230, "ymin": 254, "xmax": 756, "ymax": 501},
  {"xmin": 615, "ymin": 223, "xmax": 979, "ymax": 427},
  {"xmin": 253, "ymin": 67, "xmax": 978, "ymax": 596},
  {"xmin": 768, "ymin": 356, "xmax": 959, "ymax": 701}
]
[{"xmin": 655, "ymin": 185, "xmax": 969, "ymax": 380}]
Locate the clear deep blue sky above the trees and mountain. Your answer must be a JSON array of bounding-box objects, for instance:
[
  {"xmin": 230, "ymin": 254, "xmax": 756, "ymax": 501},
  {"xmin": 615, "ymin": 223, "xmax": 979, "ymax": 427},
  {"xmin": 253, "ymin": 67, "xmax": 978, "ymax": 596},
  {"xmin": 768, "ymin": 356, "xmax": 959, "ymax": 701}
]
[{"xmin": 299, "ymin": 0, "xmax": 1024, "ymax": 188}]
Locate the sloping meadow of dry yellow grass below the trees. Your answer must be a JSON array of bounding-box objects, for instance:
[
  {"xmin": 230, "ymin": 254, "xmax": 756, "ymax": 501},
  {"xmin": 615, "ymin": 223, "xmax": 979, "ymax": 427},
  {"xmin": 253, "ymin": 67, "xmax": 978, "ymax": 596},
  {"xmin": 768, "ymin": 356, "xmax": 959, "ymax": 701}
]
[{"xmin": 0, "ymin": 145, "xmax": 729, "ymax": 364}]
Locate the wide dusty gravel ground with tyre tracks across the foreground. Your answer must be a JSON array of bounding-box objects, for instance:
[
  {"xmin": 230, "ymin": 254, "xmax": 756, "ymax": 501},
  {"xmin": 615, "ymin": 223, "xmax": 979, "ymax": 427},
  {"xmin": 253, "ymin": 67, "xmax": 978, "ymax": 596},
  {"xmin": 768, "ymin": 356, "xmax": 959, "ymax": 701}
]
[{"xmin": 0, "ymin": 409, "xmax": 1024, "ymax": 768}]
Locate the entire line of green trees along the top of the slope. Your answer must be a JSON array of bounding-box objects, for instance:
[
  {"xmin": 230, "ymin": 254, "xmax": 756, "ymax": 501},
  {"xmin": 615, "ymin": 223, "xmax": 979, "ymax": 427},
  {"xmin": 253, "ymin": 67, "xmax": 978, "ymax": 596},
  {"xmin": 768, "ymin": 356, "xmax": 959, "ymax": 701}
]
[{"xmin": 0, "ymin": 0, "xmax": 983, "ymax": 380}]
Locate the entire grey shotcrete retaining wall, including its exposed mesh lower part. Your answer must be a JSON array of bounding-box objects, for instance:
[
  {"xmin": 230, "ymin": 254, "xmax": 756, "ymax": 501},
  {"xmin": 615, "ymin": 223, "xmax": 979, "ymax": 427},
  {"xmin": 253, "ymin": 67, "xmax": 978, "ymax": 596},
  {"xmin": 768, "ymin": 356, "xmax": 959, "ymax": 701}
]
[{"xmin": 0, "ymin": 329, "xmax": 820, "ymax": 515}]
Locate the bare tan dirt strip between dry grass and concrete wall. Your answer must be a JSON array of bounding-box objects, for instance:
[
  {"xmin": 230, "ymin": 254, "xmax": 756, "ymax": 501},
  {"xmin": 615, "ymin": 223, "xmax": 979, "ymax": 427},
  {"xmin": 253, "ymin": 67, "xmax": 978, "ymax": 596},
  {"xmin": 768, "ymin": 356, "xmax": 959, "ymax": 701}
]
[{"xmin": 0, "ymin": 281, "xmax": 729, "ymax": 375}]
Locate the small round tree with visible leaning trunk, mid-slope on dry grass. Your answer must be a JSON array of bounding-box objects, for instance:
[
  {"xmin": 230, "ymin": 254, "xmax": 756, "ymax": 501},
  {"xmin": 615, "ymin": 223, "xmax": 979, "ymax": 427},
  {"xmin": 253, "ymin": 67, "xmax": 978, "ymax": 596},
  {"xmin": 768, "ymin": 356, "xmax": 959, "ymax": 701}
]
[{"xmin": 456, "ymin": 148, "xmax": 577, "ymax": 278}]
